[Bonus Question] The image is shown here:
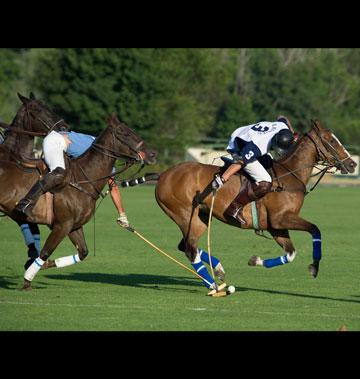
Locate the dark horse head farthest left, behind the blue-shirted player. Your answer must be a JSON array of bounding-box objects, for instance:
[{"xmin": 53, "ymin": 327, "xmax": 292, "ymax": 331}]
[{"xmin": 13, "ymin": 92, "xmax": 69, "ymax": 135}]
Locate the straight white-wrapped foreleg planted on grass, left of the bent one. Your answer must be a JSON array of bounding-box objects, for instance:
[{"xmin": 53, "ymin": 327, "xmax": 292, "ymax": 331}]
[{"xmin": 22, "ymin": 223, "xmax": 71, "ymax": 290}]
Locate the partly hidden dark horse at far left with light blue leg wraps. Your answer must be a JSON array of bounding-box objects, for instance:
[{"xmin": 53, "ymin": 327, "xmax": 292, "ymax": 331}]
[{"xmin": 0, "ymin": 92, "xmax": 68, "ymax": 269}]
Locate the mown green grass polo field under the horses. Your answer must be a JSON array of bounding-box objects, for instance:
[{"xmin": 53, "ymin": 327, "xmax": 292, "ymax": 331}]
[{"xmin": 0, "ymin": 186, "xmax": 360, "ymax": 331}]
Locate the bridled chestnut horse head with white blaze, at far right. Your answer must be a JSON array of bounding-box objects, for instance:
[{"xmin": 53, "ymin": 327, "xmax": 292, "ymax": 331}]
[{"xmin": 308, "ymin": 120, "xmax": 357, "ymax": 174}]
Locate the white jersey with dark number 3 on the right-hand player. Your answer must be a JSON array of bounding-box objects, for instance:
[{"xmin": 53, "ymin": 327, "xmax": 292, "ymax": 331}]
[{"xmin": 226, "ymin": 121, "xmax": 288, "ymax": 155}]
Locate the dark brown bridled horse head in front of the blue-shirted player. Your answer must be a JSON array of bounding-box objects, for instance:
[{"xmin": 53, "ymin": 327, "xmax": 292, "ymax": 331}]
[{"xmin": 107, "ymin": 113, "xmax": 156, "ymax": 164}]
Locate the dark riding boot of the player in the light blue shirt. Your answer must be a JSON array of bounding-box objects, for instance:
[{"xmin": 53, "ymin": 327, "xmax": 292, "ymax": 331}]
[{"xmin": 14, "ymin": 167, "xmax": 65, "ymax": 217}]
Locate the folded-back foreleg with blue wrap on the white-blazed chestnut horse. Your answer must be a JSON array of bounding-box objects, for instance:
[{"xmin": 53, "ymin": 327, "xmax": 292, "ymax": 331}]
[{"xmin": 248, "ymin": 229, "xmax": 296, "ymax": 268}]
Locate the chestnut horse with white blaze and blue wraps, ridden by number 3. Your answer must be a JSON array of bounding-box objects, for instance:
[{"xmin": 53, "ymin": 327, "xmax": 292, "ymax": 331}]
[{"xmin": 155, "ymin": 121, "xmax": 356, "ymax": 287}]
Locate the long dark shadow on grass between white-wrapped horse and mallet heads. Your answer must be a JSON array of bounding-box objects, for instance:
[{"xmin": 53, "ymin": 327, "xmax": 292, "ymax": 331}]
[{"xmin": 41, "ymin": 272, "xmax": 203, "ymax": 293}]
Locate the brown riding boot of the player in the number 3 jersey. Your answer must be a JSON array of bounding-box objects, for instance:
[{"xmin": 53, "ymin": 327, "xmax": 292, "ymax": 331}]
[{"xmin": 225, "ymin": 181, "xmax": 272, "ymax": 225}]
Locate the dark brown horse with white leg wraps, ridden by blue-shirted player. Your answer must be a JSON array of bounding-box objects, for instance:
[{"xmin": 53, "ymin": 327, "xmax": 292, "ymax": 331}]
[{"xmin": 0, "ymin": 114, "xmax": 156, "ymax": 289}]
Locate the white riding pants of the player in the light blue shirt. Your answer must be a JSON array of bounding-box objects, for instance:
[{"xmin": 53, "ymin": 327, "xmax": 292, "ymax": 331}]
[{"xmin": 43, "ymin": 131, "xmax": 67, "ymax": 171}]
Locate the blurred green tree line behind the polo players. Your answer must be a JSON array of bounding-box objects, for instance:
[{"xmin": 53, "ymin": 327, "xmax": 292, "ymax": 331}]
[{"xmin": 0, "ymin": 48, "xmax": 360, "ymax": 166}]
